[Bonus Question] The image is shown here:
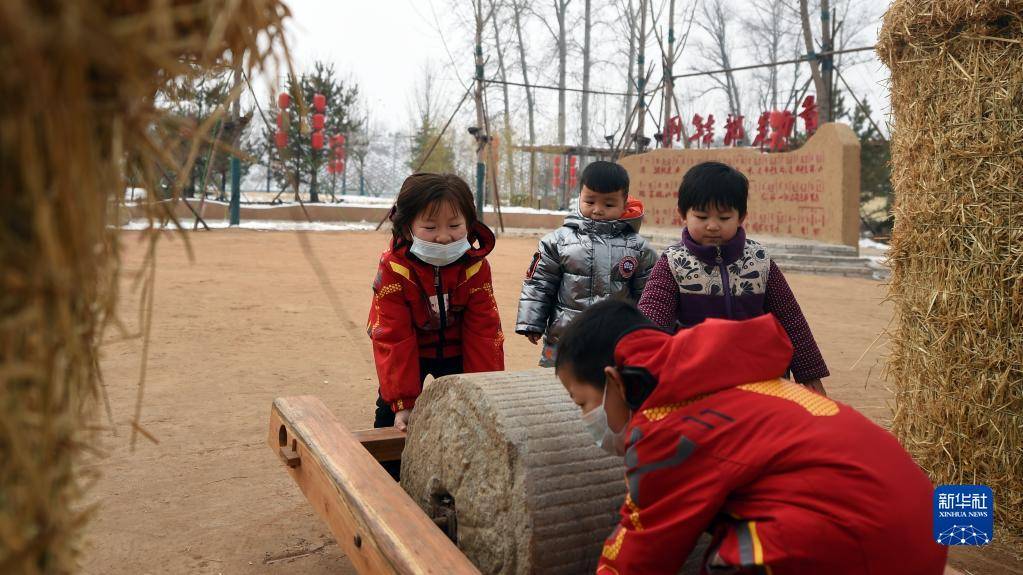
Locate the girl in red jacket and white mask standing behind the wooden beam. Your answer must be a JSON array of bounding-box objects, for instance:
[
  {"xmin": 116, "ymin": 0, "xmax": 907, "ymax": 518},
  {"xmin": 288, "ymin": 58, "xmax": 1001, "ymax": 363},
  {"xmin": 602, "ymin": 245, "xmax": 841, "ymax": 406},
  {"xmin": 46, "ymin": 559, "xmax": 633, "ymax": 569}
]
[{"xmin": 367, "ymin": 174, "xmax": 504, "ymax": 431}]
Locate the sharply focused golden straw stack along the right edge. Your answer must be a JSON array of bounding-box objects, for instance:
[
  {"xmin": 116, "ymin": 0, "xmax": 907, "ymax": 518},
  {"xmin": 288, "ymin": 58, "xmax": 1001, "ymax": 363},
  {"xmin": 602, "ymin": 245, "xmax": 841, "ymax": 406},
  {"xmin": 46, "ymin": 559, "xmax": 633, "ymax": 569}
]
[{"xmin": 878, "ymin": 0, "xmax": 1023, "ymax": 538}]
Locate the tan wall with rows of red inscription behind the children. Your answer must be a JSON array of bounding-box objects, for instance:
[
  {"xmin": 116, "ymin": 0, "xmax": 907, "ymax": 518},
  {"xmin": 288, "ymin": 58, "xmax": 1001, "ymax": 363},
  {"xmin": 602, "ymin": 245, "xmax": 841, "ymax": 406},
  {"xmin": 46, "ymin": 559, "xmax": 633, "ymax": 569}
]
[{"xmin": 620, "ymin": 124, "xmax": 859, "ymax": 246}]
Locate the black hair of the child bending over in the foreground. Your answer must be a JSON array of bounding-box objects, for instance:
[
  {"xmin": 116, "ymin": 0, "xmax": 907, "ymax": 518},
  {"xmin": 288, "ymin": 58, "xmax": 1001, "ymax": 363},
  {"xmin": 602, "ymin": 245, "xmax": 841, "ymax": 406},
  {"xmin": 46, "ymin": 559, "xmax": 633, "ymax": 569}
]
[{"xmin": 554, "ymin": 300, "xmax": 654, "ymax": 391}]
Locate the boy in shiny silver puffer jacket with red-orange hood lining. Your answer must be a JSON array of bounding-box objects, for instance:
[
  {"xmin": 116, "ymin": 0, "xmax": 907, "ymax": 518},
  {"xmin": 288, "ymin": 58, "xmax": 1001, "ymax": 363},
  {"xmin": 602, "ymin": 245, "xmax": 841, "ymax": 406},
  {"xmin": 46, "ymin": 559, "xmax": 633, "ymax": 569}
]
[{"xmin": 515, "ymin": 162, "xmax": 657, "ymax": 367}]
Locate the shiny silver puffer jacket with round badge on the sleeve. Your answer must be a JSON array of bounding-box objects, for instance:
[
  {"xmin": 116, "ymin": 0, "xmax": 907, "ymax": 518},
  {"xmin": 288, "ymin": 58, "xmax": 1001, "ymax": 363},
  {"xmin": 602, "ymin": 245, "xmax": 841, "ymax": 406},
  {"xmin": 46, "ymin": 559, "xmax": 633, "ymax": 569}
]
[{"xmin": 515, "ymin": 209, "xmax": 657, "ymax": 345}]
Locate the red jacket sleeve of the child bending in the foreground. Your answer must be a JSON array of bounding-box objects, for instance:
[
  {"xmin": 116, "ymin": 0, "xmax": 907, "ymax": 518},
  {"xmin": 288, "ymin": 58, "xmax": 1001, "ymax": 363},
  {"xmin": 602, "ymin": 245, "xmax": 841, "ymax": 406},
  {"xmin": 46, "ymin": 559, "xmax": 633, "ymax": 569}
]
[{"xmin": 596, "ymin": 426, "xmax": 731, "ymax": 575}]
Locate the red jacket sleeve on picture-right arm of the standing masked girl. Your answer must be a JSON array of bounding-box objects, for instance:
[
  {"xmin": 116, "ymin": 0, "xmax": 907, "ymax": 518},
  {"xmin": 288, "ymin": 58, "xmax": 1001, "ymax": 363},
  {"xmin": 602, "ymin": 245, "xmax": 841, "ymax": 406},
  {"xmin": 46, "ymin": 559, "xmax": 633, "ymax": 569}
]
[{"xmin": 461, "ymin": 260, "xmax": 504, "ymax": 373}]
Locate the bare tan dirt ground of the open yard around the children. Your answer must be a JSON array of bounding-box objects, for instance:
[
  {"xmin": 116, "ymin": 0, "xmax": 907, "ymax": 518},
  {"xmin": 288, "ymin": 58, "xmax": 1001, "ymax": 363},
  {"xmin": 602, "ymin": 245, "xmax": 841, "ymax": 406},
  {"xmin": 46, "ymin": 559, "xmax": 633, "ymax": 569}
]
[{"xmin": 83, "ymin": 230, "xmax": 1023, "ymax": 574}]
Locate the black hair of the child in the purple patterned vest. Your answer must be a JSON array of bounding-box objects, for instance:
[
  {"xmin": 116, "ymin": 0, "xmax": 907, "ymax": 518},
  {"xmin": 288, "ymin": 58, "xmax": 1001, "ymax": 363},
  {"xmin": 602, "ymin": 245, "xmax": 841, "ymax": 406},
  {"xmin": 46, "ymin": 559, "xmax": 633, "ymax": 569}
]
[{"xmin": 678, "ymin": 162, "xmax": 750, "ymax": 219}]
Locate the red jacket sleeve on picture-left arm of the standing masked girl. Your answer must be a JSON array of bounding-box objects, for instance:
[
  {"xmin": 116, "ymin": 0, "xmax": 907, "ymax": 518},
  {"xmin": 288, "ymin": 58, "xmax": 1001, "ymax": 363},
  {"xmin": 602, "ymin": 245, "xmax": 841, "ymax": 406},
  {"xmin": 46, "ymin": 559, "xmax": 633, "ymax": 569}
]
[{"xmin": 367, "ymin": 258, "xmax": 421, "ymax": 412}]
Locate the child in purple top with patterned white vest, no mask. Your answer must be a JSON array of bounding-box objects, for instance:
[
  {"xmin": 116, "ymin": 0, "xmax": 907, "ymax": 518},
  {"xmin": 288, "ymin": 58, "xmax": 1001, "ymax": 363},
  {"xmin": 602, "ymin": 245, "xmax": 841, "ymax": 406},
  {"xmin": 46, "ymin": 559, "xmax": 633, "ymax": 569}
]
[{"xmin": 639, "ymin": 162, "xmax": 830, "ymax": 393}]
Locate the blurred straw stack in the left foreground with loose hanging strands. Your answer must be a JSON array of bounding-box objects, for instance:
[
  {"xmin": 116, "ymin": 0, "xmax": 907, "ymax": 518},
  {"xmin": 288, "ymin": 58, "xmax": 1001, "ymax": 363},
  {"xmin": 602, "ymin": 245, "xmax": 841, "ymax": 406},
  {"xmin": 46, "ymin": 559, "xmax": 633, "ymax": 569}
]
[{"xmin": 0, "ymin": 0, "xmax": 287, "ymax": 573}]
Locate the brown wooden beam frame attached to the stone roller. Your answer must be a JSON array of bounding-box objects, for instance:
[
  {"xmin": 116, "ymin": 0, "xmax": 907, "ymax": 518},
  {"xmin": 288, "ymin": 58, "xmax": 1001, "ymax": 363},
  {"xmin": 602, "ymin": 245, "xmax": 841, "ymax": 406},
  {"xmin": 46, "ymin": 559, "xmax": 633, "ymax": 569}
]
[{"xmin": 267, "ymin": 396, "xmax": 479, "ymax": 574}]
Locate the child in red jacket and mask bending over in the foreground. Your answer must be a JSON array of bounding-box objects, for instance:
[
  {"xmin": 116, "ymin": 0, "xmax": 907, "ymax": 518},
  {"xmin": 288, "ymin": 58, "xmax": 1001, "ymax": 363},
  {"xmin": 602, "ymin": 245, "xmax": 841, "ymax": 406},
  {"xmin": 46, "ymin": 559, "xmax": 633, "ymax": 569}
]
[{"xmin": 555, "ymin": 301, "xmax": 947, "ymax": 575}]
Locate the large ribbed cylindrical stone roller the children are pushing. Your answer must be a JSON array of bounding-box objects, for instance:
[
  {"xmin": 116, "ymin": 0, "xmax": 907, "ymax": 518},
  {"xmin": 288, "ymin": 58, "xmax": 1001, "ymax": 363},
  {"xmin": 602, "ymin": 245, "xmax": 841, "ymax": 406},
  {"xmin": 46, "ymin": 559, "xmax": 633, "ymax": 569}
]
[{"xmin": 401, "ymin": 369, "xmax": 625, "ymax": 574}]
